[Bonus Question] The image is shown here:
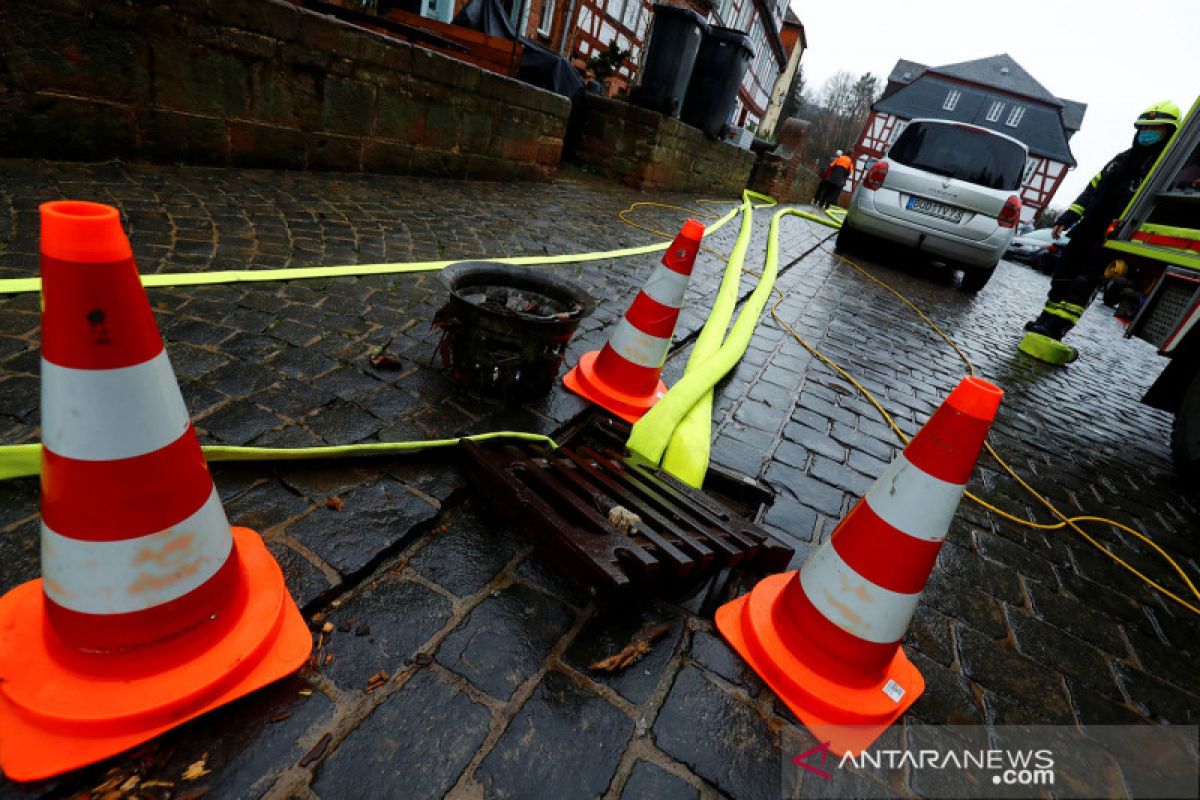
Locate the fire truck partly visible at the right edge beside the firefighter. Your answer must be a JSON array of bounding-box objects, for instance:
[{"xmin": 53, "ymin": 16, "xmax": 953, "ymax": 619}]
[{"xmin": 1105, "ymin": 98, "xmax": 1200, "ymax": 479}]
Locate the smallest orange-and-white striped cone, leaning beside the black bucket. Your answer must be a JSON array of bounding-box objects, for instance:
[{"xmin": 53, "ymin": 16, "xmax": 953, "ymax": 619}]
[{"xmin": 563, "ymin": 219, "xmax": 704, "ymax": 422}]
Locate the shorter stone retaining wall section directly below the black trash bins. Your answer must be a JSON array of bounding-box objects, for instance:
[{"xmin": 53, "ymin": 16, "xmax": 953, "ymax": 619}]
[{"xmin": 570, "ymin": 95, "xmax": 755, "ymax": 194}]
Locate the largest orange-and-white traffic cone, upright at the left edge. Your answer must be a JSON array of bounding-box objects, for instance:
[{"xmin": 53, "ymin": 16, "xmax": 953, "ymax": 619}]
[{"xmin": 0, "ymin": 201, "xmax": 312, "ymax": 781}]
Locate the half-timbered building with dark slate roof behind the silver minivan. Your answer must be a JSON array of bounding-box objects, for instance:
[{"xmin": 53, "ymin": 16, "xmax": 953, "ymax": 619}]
[{"xmin": 852, "ymin": 53, "xmax": 1087, "ymax": 219}]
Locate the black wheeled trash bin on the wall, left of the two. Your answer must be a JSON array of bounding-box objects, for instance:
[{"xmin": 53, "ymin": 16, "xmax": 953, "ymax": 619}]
[{"xmin": 629, "ymin": 4, "xmax": 708, "ymax": 116}]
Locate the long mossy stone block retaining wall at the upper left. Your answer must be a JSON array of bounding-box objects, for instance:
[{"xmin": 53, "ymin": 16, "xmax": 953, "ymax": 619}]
[{"xmin": 0, "ymin": 0, "xmax": 570, "ymax": 179}]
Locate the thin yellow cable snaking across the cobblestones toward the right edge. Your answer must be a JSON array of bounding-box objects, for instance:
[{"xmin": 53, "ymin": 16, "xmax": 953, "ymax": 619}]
[{"xmin": 618, "ymin": 203, "xmax": 1200, "ymax": 615}]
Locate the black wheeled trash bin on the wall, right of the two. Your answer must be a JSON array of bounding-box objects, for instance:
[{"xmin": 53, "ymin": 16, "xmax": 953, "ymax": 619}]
[{"xmin": 679, "ymin": 25, "xmax": 754, "ymax": 139}]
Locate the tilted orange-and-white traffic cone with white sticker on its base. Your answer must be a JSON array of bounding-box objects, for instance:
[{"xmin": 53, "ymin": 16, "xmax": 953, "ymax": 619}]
[{"xmin": 716, "ymin": 378, "xmax": 1003, "ymax": 754}]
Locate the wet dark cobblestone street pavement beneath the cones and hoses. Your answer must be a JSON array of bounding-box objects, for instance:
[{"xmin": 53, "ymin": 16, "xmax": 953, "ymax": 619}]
[{"xmin": 0, "ymin": 161, "xmax": 1200, "ymax": 799}]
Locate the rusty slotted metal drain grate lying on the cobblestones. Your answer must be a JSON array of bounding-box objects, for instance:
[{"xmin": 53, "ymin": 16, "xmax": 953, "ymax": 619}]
[{"xmin": 460, "ymin": 440, "xmax": 793, "ymax": 600}]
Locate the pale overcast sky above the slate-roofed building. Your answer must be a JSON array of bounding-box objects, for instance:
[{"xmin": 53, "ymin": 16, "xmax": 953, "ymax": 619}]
[{"xmin": 791, "ymin": 0, "xmax": 1200, "ymax": 207}]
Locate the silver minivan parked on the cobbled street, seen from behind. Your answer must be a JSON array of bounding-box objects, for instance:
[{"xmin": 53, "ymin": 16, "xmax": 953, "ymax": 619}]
[{"xmin": 838, "ymin": 120, "xmax": 1028, "ymax": 291}]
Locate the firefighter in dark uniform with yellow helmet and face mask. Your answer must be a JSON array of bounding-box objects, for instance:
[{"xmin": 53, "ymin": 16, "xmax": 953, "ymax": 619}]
[{"xmin": 1020, "ymin": 101, "xmax": 1180, "ymax": 363}]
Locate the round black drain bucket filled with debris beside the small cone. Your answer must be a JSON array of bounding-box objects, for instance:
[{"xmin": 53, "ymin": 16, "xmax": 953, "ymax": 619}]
[{"xmin": 433, "ymin": 261, "xmax": 593, "ymax": 402}]
